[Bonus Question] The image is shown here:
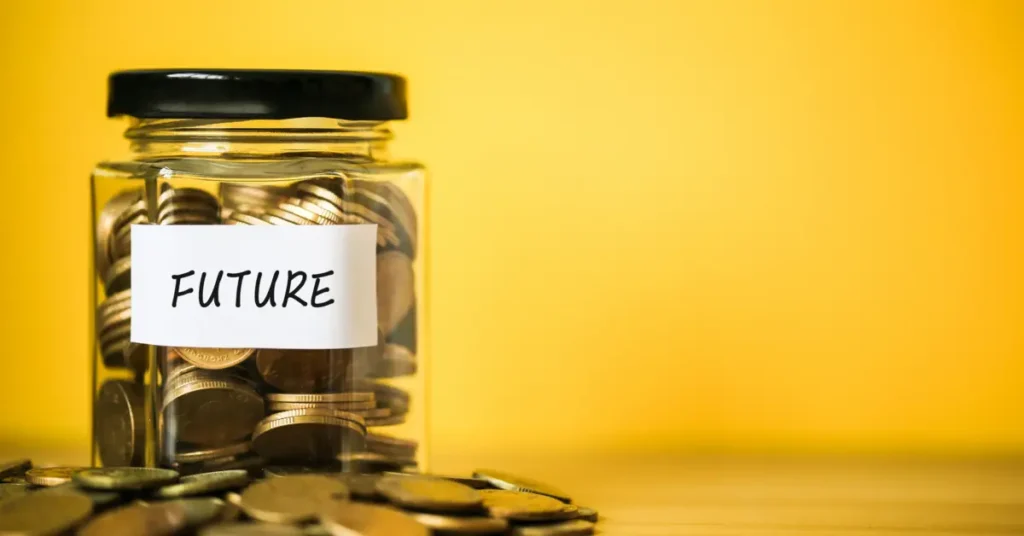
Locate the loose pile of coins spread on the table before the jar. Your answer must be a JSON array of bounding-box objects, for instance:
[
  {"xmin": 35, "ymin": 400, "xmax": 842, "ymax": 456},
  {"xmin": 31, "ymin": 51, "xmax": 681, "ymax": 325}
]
[{"xmin": 0, "ymin": 460, "xmax": 598, "ymax": 536}]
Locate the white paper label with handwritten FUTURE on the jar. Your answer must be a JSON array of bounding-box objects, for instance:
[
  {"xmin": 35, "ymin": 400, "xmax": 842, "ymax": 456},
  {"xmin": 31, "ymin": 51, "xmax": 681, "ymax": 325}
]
[{"xmin": 131, "ymin": 224, "xmax": 377, "ymax": 349}]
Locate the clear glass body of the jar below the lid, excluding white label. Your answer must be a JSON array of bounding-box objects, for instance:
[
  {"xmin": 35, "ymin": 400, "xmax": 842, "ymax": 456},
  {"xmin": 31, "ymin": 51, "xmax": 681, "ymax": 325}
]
[{"xmin": 92, "ymin": 119, "xmax": 427, "ymax": 472}]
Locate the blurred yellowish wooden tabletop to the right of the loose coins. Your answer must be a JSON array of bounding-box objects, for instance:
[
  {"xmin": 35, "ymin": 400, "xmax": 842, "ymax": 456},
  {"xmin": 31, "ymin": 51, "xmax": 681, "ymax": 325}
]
[{"xmin": 433, "ymin": 456, "xmax": 1024, "ymax": 536}]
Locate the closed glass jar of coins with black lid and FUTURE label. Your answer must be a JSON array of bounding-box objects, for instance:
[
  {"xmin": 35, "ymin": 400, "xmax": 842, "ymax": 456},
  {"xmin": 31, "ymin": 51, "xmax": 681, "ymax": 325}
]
[{"xmin": 86, "ymin": 70, "xmax": 427, "ymax": 473}]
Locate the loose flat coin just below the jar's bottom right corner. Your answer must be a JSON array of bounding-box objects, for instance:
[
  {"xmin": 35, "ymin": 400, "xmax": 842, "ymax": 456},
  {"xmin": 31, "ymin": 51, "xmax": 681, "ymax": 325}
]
[{"xmin": 377, "ymin": 476, "xmax": 483, "ymax": 512}]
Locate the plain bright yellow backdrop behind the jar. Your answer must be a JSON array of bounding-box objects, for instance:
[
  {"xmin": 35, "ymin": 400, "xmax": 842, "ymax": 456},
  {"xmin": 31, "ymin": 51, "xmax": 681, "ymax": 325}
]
[{"xmin": 0, "ymin": 0, "xmax": 1024, "ymax": 461}]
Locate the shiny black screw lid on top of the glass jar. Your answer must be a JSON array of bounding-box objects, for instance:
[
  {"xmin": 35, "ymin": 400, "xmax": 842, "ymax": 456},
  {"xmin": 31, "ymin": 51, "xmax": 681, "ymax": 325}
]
[{"xmin": 106, "ymin": 69, "xmax": 409, "ymax": 121}]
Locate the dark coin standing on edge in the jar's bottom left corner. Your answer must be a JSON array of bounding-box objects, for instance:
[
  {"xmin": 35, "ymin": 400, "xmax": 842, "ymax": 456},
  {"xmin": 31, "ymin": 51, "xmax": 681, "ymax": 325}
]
[{"xmin": 93, "ymin": 380, "xmax": 145, "ymax": 466}]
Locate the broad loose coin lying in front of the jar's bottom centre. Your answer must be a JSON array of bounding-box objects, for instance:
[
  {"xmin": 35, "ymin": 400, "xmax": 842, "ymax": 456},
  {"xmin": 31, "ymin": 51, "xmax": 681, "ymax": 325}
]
[{"xmin": 241, "ymin": 475, "xmax": 348, "ymax": 523}]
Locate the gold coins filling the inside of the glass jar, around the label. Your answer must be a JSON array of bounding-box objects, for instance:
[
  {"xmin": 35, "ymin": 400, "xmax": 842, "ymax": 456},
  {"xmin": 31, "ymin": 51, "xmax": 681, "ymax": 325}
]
[{"xmin": 94, "ymin": 175, "xmax": 418, "ymax": 475}]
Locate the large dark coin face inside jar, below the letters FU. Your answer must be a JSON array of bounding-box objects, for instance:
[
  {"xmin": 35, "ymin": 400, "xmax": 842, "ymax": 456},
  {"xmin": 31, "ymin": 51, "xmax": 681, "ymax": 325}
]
[{"xmin": 163, "ymin": 371, "xmax": 263, "ymax": 448}]
